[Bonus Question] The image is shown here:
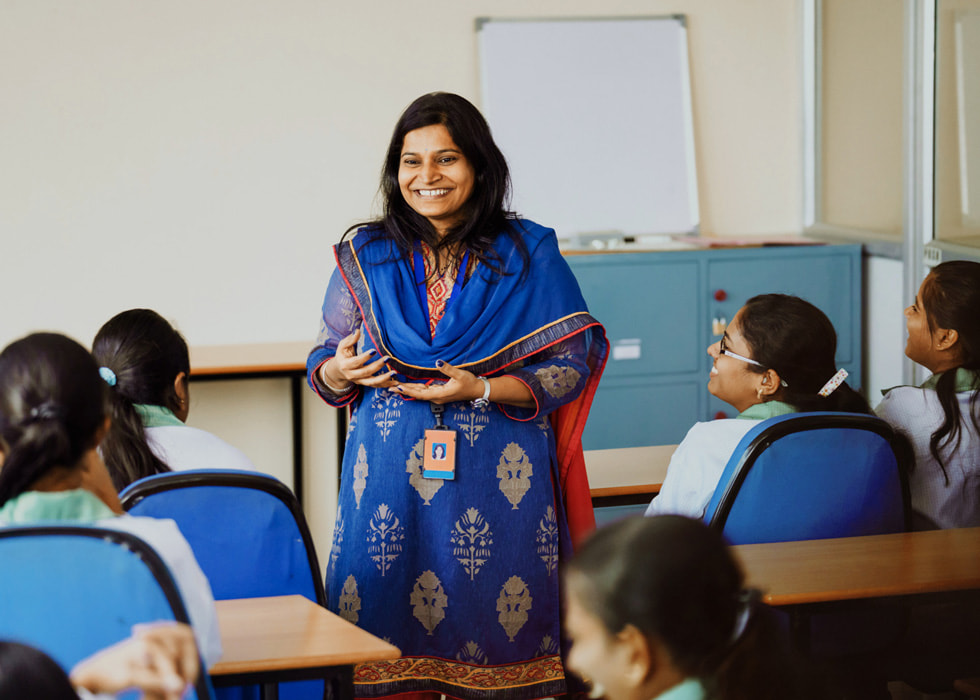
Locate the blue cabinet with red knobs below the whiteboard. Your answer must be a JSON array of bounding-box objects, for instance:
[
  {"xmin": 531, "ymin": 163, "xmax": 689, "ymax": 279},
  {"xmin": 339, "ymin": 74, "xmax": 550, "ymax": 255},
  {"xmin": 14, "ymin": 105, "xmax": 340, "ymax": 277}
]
[{"xmin": 566, "ymin": 245, "xmax": 862, "ymax": 449}]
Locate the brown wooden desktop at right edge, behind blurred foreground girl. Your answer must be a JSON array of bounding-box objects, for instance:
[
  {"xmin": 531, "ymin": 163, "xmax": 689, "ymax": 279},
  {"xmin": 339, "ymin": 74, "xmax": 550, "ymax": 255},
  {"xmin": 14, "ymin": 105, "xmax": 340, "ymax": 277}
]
[{"xmin": 734, "ymin": 527, "xmax": 980, "ymax": 606}]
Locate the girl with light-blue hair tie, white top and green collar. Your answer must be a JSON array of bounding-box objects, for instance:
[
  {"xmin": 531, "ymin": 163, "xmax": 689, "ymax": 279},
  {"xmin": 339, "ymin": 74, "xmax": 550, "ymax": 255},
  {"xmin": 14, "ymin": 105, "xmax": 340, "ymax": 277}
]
[{"xmin": 92, "ymin": 309, "xmax": 255, "ymax": 491}]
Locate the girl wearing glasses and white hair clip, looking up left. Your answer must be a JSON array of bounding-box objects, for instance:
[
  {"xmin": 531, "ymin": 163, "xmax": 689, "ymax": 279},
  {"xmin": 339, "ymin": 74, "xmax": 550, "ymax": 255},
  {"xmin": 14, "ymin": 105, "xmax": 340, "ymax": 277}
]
[{"xmin": 647, "ymin": 294, "xmax": 871, "ymax": 518}]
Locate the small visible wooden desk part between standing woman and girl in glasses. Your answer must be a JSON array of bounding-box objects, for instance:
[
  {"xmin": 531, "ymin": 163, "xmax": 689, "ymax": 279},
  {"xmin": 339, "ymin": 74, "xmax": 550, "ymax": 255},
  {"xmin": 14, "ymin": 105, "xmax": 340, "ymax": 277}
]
[{"xmin": 585, "ymin": 445, "xmax": 677, "ymax": 503}]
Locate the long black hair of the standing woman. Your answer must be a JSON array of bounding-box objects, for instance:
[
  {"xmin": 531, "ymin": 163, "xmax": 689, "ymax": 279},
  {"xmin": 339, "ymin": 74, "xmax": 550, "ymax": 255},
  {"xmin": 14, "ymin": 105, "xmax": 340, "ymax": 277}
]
[{"xmin": 344, "ymin": 92, "xmax": 530, "ymax": 274}]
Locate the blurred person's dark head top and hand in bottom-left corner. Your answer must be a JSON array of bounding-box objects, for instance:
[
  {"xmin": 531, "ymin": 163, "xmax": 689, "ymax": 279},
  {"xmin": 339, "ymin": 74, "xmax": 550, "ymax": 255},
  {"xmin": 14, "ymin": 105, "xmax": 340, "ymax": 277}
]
[{"xmin": 0, "ymin": 623, "xmax": 200, "ymax": 700}]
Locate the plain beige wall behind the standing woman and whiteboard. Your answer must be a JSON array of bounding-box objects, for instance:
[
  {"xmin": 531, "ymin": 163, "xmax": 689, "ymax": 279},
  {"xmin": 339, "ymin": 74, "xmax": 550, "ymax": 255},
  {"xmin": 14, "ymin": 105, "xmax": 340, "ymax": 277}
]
[{"xmin": 0, "ymin": 0, "xmax": 802, "ymax": 561}]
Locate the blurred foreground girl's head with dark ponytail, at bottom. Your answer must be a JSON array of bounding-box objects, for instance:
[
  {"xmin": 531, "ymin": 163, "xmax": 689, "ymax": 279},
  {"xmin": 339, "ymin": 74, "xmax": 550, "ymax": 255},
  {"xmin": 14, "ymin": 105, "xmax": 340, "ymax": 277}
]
[{"xmin": 565, "ymin": 515, "xmax": 819, "ymax": 700}]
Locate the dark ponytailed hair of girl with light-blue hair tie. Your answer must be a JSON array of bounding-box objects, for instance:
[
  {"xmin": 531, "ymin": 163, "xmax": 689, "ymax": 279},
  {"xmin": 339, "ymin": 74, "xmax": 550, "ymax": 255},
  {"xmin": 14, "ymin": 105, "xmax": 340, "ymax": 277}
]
[{"xmin": 92, "ymin": 309, "xmax": 191, "ymax": 491}]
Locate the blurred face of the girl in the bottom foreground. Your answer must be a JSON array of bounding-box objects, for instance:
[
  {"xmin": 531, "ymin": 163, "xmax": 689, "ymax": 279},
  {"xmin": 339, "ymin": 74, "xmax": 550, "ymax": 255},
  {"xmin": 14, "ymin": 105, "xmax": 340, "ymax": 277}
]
[{"xmin": 565, "ymin": 586, "xmax": 637, "ymax": 700}]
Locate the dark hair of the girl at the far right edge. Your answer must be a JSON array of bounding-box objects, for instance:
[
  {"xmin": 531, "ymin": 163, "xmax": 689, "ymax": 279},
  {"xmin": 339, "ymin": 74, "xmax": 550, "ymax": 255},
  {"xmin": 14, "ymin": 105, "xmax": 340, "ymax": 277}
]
[{"xmin": 922, "ymin": 260, "xmax": 980, "ymax": 484}]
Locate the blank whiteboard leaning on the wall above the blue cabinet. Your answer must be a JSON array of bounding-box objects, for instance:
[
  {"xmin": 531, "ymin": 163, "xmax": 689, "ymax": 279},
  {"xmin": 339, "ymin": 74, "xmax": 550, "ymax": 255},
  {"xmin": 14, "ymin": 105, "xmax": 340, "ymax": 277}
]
[{"xmin": 477, "ymin": 15, "xmax": 699, "ymax": 238}]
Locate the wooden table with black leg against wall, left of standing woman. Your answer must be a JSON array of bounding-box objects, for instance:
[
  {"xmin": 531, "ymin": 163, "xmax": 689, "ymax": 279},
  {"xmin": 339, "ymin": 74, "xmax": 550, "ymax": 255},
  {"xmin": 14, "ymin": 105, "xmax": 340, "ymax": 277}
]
[{"xmin": 190, "ymin": 340, "xmax": 314, "ymax": 503}]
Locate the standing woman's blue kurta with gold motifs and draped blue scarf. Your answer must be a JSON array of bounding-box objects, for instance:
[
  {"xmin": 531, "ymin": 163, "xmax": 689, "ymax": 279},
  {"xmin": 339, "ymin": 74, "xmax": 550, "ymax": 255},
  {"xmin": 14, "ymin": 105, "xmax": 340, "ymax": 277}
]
[{"xmin": 309, "ymin": 222, "xmax": 605, "ymax": 698}]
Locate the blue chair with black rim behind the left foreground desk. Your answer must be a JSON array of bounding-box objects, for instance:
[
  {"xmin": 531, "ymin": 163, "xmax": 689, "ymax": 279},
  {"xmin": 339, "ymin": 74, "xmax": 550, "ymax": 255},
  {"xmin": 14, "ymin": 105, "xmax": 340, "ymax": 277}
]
[{"xmin": 120, "ymin": 469, "xmax": 326, "ymax": 700}]
